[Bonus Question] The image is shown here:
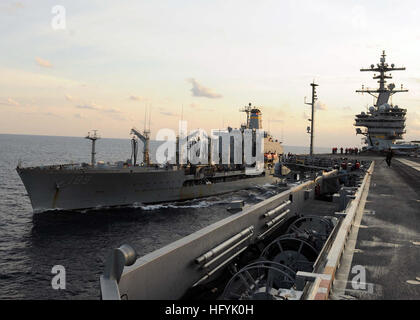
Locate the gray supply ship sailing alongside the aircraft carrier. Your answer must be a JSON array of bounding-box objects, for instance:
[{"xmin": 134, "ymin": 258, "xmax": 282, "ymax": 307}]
[{"xmin": 16, "ymin": 104, "xmax": 283, "ymax": 212}]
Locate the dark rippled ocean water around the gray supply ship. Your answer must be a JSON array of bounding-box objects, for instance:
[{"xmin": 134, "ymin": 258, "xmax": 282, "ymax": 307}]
[{"xmin": 0, "ymin": 134, "xmax": 330, "ymax": 299}]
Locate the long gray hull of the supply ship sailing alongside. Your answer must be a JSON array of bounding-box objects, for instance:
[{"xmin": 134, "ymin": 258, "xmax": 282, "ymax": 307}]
[{"xmin": 17, "ymin": 168, "xmax": 278, "ymax": 212}]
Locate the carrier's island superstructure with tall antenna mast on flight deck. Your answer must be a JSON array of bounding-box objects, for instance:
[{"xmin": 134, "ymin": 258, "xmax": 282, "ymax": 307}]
[{"xmin": 354, "ymin": 51, "xmax": 408, "ymax": 151}]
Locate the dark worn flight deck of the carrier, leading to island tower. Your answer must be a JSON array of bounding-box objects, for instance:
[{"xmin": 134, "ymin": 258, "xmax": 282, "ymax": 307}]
[{"xmin": 330, "ymin": 156, "xmax": 420, "ymax": 300}]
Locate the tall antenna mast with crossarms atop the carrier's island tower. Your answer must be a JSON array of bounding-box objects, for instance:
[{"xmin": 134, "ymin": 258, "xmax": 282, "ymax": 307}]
[{"xmin": 356, "ymin": 50, "xmax": 408, "ymax": 107}]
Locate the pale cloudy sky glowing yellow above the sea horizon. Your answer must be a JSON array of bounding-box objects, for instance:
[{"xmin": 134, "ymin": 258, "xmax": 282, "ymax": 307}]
[{"xmin": 0, "ymin": 0, "xmax": 420, "ymax": 147}]
